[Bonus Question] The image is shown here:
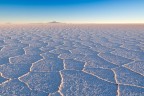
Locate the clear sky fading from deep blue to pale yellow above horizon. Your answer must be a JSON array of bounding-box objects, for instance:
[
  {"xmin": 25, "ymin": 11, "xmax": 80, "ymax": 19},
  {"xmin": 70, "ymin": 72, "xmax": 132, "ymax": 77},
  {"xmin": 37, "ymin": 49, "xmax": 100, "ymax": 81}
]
[{"xmin": 0, "ymin": 0, "xmax": 144, "ymax": 23}]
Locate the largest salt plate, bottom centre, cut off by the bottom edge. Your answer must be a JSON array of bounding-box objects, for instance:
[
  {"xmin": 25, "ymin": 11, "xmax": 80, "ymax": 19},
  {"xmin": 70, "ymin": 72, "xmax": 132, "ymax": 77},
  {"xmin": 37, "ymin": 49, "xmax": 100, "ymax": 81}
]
[{"xmin": 60, "ymin": 70, "xmax": 117, "ymax": 96}]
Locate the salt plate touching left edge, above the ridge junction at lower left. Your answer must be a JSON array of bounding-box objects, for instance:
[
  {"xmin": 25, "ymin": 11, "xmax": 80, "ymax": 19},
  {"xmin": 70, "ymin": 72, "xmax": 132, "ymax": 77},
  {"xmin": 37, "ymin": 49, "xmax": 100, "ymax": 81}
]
[{"xmin": 0, "ymin": 64, "xmax": 31, "ymax": 78}]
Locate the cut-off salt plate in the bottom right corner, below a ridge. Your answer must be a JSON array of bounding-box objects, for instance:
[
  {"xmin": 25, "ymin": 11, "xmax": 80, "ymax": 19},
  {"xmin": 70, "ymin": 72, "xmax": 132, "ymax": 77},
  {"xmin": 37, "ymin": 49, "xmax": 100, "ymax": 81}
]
[{"xmin": 119, "ymin": 85, "xmax": 144, "ymax": 96}]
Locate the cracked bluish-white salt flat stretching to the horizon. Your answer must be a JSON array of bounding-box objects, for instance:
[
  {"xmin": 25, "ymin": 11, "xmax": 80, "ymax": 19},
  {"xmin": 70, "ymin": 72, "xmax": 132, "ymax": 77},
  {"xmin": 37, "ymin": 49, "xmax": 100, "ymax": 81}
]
[{"xmin": 0, "ymin": 24, "xmax": 144, "ymax": 96}]
